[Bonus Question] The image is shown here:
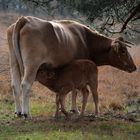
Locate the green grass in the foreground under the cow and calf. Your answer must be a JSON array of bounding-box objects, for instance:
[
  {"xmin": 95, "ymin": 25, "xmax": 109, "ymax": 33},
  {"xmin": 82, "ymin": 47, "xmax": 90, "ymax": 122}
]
[{"xmin": 0, "ymin": 95, "xmax": 140, "ymax": 140}]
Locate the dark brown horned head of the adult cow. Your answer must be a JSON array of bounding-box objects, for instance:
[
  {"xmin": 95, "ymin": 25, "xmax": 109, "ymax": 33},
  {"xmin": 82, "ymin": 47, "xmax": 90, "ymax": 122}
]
[{"xmin": 109, "ymin": 37, "xmax": 136, "ymax": 73}]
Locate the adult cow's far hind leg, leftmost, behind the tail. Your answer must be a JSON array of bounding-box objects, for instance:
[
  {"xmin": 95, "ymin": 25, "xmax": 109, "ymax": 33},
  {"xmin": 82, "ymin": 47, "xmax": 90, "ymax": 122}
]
[{"xmin": 7, "ymin": 25, "xmax": 21, "ymax": 117}]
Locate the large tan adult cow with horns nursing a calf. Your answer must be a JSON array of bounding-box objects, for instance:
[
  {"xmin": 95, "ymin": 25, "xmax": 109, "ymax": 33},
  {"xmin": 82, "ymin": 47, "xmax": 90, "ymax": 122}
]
[{"xmin": 7, "ymin": 16, "xmax": 136, "ymax": 117}]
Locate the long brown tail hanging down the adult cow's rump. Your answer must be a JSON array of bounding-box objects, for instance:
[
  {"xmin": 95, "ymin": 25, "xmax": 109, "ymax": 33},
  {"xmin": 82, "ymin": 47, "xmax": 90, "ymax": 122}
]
[{"xmin": 12, "ymin": 17, "xmax": 28, "ymax": 76}]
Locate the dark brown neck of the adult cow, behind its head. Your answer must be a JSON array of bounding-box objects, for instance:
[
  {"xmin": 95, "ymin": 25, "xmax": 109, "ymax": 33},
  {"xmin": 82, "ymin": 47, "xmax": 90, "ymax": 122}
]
[{"xmin": 88, "ymin": 29, "xmax": 112, "ymax": 66}]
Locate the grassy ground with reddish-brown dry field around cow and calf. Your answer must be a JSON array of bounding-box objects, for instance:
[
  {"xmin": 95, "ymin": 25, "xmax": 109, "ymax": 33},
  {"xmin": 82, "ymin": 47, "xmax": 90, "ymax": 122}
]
[{"xmin": 0, "ymin": 12, "xmax": 140, "ymax": 140}]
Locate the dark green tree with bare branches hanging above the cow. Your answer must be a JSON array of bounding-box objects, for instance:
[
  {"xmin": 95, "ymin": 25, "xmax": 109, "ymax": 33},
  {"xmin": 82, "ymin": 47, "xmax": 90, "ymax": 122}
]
[{"xmin": 22, "ymin": 0, "xmax": 140, "ymax": 33}]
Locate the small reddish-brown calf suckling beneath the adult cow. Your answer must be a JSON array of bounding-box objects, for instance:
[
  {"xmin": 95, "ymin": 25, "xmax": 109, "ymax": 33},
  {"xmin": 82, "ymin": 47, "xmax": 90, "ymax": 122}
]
[{"xmin": 36, "ymin": 60, "xmax": 98, "ymax": 117}]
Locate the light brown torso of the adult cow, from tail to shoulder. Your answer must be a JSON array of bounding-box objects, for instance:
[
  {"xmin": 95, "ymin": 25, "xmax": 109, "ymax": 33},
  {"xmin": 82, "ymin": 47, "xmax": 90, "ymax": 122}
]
[{"xmin": 20, "ymin": 17, "xmax": 88, "ymax": 67}]
